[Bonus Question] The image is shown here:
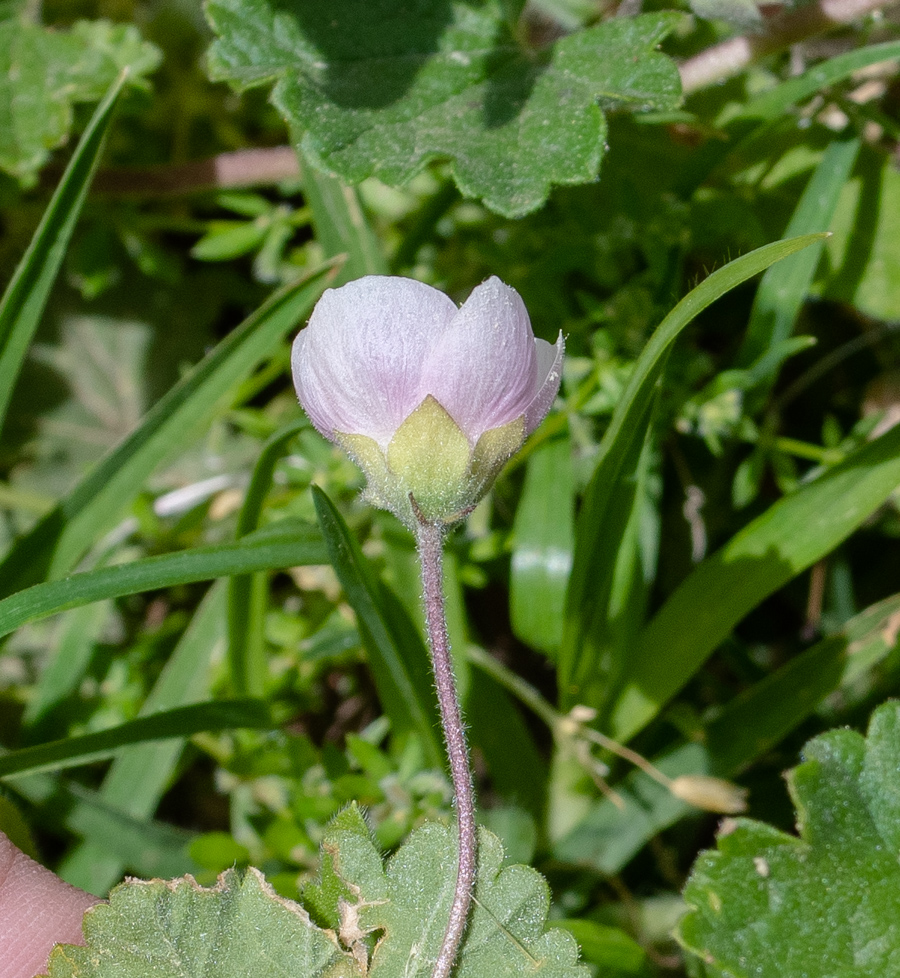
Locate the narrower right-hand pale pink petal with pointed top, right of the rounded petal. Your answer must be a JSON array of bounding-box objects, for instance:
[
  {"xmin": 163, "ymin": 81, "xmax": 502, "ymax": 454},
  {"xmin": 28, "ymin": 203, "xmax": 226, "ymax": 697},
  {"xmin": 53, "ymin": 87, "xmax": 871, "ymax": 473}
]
[{"xmin": 420, "ymin": 278, "xmax": 537, "ymax": 445}]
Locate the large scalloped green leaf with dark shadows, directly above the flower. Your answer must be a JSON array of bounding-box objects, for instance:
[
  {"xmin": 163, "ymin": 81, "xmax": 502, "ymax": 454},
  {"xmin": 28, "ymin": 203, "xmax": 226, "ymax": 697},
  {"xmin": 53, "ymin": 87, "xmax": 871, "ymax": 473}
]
[{"xmin": 206, "ymin": 0, "xmax": 681, "ymax": 217}]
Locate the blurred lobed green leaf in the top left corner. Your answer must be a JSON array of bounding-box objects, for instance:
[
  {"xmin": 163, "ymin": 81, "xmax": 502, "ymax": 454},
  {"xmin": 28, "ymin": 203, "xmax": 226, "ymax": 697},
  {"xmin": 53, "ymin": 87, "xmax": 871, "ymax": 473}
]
[{"xmin": 0, "ymin": 18, "xmax": 162, "ymax": 182}]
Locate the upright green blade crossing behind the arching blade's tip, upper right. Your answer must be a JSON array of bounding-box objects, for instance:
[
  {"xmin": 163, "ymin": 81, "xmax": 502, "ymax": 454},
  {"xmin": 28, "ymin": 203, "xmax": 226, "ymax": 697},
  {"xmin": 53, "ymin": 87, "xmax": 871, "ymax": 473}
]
[{"xmin": 738, "ymin": 133, "xmax": 860, "ymax": 366}]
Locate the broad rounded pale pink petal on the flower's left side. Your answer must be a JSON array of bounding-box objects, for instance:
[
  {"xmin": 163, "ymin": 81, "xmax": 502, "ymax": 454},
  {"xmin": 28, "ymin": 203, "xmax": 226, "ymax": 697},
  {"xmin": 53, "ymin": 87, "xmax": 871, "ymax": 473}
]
[{"xmin": 291, "ymin": 275, "xmax": 457, "ymax": 448}]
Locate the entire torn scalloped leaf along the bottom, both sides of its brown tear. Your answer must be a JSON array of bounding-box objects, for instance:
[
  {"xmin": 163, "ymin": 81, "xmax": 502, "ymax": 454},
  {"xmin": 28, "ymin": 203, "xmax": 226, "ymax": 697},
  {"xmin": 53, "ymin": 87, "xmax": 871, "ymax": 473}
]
[{"xmin": 46, "ymin": 807, "xmax": 589, "ymax": 978}]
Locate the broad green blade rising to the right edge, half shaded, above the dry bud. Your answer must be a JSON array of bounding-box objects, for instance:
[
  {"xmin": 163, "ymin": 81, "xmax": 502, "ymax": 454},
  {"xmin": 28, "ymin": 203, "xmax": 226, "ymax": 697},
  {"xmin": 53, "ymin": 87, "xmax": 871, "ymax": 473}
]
[{"xmin": 610, "ymin": 420, "xmax": 900, "ymax": 741}]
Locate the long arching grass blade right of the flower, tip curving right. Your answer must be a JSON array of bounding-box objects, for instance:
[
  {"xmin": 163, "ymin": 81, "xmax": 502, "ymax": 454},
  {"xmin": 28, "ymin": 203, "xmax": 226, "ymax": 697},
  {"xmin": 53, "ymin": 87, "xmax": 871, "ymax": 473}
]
[{"xmin": 560, "ymin": 235, "xmax": 822, "ymax": 708}]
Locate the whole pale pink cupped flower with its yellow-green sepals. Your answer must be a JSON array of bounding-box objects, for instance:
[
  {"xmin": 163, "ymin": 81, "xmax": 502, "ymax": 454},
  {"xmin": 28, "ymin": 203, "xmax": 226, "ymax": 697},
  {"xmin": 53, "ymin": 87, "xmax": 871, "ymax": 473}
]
[{"xmin": 291, "ymin": 275, "xmax": 563, "ymax": 526}]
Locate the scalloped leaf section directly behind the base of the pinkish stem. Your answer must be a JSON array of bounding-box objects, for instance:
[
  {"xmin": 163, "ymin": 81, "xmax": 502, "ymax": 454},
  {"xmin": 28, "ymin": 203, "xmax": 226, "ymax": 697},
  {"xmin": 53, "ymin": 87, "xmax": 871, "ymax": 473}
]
[{"xmin": 324, "ymin": 809, "xmax": 590, "ymax": 978}]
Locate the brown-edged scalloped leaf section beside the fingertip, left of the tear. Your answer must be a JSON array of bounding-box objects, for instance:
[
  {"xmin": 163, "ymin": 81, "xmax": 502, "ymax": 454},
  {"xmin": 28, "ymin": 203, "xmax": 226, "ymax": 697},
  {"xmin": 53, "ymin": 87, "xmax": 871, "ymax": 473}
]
[{"xmin": 45, "ymin": 869, "xmax": 359, "ymax": 978}]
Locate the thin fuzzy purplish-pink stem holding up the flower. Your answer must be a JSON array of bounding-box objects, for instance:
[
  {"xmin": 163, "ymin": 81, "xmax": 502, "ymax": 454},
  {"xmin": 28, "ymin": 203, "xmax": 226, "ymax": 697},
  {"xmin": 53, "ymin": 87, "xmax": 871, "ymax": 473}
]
[{"xmin": 412, "ymin": 500, "xmax": 478, "ymax": 978}]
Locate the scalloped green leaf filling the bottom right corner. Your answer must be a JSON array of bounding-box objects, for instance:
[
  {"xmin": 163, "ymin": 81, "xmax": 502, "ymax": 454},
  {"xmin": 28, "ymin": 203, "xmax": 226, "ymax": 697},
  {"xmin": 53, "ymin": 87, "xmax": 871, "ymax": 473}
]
[{"xmin": 678, "ymin": 702, "xmax": 900, "ymax": 978}]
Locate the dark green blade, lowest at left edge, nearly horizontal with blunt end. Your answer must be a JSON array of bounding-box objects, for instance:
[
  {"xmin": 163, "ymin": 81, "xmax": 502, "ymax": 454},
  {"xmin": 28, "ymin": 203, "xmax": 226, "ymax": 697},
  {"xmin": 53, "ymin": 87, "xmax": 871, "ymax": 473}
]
[{"xmin": 0, "ymin": 699, "xmax": 273, "ymax": 778}]
